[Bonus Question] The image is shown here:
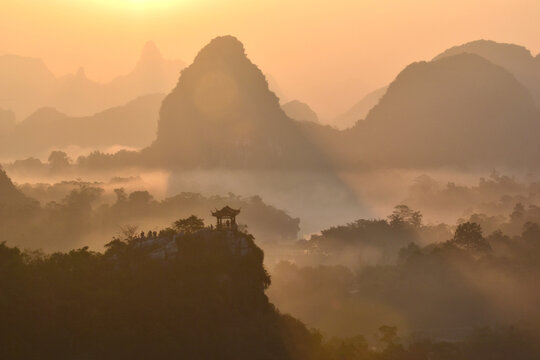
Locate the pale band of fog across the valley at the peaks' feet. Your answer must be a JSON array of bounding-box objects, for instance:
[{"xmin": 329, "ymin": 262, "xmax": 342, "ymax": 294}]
[{"xmin": 7, "ymin": 161, "xmax": 537, "ymax": 238}]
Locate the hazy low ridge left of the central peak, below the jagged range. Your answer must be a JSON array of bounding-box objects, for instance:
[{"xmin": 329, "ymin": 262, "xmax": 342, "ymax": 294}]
[{"xmin": 0, "ymin": 94, "xmax": 164, "ymax": 158}]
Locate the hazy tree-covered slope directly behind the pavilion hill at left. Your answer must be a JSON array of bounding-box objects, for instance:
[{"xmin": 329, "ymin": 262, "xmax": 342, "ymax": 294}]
[{"xmin": 0, "ymin": 171, "xmax": 300, "ymax": 250}]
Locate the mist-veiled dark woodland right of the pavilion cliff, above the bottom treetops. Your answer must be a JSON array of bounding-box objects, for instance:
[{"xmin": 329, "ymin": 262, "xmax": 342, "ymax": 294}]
[{"xmin": 269, "ymin": 208, "xmax": 540, "ymax": 341}]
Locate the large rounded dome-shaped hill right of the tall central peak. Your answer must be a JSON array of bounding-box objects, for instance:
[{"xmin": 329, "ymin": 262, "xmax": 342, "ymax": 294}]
[{"xmin": 342, "ymin": 54, "xmax": 540, "ymax": 166}]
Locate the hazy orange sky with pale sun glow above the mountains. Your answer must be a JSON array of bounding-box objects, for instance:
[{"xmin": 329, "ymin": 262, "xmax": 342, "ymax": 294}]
[{"xmin": 0, "ymin": 0, "xmax": 540, "ymax": 117}]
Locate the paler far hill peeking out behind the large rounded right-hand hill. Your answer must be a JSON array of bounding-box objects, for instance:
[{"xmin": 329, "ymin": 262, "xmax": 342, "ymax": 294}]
[{"xmin": 435, "ymin": 40, "xmax": 540, "ymax": 105}]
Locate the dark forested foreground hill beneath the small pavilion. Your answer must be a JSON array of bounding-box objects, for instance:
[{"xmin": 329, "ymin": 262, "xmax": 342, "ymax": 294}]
[{"xmin": 0, "ymin": 229, "xmax": 320, "ymax": 360}]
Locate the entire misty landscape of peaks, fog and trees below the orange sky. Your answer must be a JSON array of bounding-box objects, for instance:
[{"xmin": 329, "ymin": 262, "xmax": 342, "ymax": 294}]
[{"xmin": 0, "ymin": 22, "xmax": 540, "ymax": 360}]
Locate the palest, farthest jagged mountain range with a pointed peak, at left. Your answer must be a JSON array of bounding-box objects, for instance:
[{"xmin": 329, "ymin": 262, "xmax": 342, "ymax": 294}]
[{"xmin": 0, "ymin": 42, "xmax": 184, "ymax": 121}]
